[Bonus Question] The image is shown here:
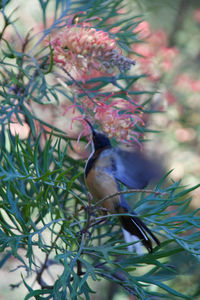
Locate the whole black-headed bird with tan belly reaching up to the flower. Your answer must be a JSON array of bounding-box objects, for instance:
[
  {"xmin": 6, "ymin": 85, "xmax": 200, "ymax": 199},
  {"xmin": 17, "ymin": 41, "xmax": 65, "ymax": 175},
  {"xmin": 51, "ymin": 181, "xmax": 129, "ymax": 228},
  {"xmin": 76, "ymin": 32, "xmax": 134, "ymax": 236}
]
[{"xmin": 85, "ymin": 119, "xmax": 160, "ymax": 252}]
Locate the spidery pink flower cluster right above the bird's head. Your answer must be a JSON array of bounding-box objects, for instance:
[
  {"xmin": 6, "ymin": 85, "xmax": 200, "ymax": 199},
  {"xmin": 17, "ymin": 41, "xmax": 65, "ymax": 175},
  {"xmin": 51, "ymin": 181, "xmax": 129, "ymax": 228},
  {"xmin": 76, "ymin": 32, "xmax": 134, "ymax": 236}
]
[{"xmin": 62, "ymin": 95, "xmax": 144, "ymax": 144}]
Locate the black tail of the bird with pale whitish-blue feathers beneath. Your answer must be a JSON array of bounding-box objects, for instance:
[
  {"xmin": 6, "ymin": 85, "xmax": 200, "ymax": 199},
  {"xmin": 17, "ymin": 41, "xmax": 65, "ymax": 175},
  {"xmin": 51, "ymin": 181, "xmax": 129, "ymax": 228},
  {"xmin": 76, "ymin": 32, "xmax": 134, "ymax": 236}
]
[{"xmin": 119, "ymin": 209, "xmax": 160, "ymax": 253}]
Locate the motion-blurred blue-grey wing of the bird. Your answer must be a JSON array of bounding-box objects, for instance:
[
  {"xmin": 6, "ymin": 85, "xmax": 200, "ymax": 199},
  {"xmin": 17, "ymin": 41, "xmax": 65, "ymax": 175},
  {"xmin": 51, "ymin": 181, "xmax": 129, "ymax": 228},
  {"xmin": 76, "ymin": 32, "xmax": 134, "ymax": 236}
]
[{"xmin": 113, "ymin": 148, "xmax": 160, "ymax": 189}]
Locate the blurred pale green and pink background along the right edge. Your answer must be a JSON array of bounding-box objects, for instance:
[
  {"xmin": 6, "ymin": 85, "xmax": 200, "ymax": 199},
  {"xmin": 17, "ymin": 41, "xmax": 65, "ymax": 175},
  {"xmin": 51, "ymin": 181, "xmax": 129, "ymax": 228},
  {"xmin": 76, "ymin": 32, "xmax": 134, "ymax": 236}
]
[{"xmin": 133, "ymin": 0, "xmax": 200, "ymax": 211}]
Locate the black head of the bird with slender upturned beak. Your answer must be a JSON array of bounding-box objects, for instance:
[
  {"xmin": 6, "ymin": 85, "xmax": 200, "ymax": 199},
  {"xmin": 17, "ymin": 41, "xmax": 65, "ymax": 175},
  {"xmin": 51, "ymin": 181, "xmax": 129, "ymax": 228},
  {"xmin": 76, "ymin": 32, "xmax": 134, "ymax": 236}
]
[{"xmin": 85, "ymin": 119, "xmax": 112, "ymax": 151}]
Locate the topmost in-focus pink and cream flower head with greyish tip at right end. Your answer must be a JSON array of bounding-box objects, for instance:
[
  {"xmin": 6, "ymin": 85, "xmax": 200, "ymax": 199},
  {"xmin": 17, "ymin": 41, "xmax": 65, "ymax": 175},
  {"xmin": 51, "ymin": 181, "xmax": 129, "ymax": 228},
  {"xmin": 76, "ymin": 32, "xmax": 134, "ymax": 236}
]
[{"xmin": 51, "ymin": 23, "xmax": 135, "ymax": 81}]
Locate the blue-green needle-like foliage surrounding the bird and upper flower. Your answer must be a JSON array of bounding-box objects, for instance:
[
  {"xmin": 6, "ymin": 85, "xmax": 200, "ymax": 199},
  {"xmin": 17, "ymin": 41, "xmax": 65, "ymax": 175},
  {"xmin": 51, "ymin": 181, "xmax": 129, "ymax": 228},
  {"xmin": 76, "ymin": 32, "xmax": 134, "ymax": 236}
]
[{"xmin": 0, "ymin": 0, "xmax": 200, "ymax": 299}]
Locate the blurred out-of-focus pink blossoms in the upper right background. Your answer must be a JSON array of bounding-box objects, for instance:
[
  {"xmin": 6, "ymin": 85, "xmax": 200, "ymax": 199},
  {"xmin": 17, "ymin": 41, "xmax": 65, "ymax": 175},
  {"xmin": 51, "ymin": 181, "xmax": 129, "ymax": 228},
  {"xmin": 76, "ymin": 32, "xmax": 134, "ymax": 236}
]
[{"xmin": 133, "ymin": 20, "xmax": 200, "ymax": 109}]
